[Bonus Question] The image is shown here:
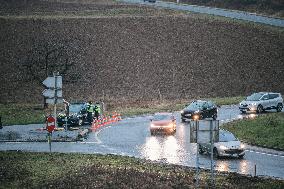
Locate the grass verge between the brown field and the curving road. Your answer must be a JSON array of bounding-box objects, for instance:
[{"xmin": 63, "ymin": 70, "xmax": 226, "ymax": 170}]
[{"xmin": 0, "ymin": 97, "xmax": 243, "ymax": 125}]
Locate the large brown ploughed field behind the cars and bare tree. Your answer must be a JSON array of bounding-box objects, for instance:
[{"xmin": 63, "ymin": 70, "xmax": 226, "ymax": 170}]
[{"xmin": 0, "ymin": 0, "xmax": 284, "ymax": 103}]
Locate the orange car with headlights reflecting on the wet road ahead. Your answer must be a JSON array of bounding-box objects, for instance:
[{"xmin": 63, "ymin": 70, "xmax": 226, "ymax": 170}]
[{"xmin": 150, "ymin": 113, "xmax": 176, "ymax": 135}]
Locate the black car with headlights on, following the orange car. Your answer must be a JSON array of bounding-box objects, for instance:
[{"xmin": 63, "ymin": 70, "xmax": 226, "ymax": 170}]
[{"xmin": 181, "ymin": 100, "xmax": 218, "ymax": 122}]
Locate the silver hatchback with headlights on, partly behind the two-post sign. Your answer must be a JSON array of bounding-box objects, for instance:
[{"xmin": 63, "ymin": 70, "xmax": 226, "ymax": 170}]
[{"xmin": 199, "ymin": 129, "xmax": 245, "ymax": 158}]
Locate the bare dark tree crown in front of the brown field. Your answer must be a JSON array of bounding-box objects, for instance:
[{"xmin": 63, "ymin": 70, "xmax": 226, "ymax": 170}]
[{"xmin": 20, "ymin": 39, "xmax": 81, "ymax": 107}]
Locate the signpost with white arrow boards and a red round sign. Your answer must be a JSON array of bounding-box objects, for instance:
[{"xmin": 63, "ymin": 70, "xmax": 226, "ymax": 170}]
[{"xmin": 42, "ymin": 72, "xmax": 63, "ymax": 152}]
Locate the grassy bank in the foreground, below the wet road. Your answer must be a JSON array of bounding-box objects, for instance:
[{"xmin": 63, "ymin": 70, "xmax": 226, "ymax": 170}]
[{"xmin": 0, "ymin": 152, "xmax": 284, "ymax": 188}]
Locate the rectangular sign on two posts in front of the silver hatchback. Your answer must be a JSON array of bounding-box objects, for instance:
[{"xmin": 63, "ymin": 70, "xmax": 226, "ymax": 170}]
[{"xmin": 190, "ymin": 120, "xmax": 219, "ymax": 188}]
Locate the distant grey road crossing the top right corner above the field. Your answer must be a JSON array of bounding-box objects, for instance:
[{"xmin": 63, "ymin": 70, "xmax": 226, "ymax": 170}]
[{"xmin": 120, "ymin": 0, "xmax": 284, "ymax": 27}]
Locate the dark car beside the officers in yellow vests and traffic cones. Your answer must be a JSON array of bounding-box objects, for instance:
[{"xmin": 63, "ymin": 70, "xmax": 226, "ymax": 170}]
[{"xmin": 57, "ymin": 103, "xmax": 87, "ymax": 127}]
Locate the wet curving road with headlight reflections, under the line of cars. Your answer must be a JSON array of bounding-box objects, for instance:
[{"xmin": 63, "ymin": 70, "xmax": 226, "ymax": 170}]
[{"xmin": 0, "ymin": 106, "xmax": 284, "ymax": 179}]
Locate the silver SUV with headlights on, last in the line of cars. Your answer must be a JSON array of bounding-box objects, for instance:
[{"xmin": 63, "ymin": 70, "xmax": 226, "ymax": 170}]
[{"xmin": 239, "ymin": 92, "xmax": 283, "ymax": 113}]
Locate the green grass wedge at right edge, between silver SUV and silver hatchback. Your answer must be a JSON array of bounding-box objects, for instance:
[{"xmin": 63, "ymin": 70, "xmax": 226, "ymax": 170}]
[{"xmin": 222, "ymin": 112, "xmax": 284, "ymax": 150}]
